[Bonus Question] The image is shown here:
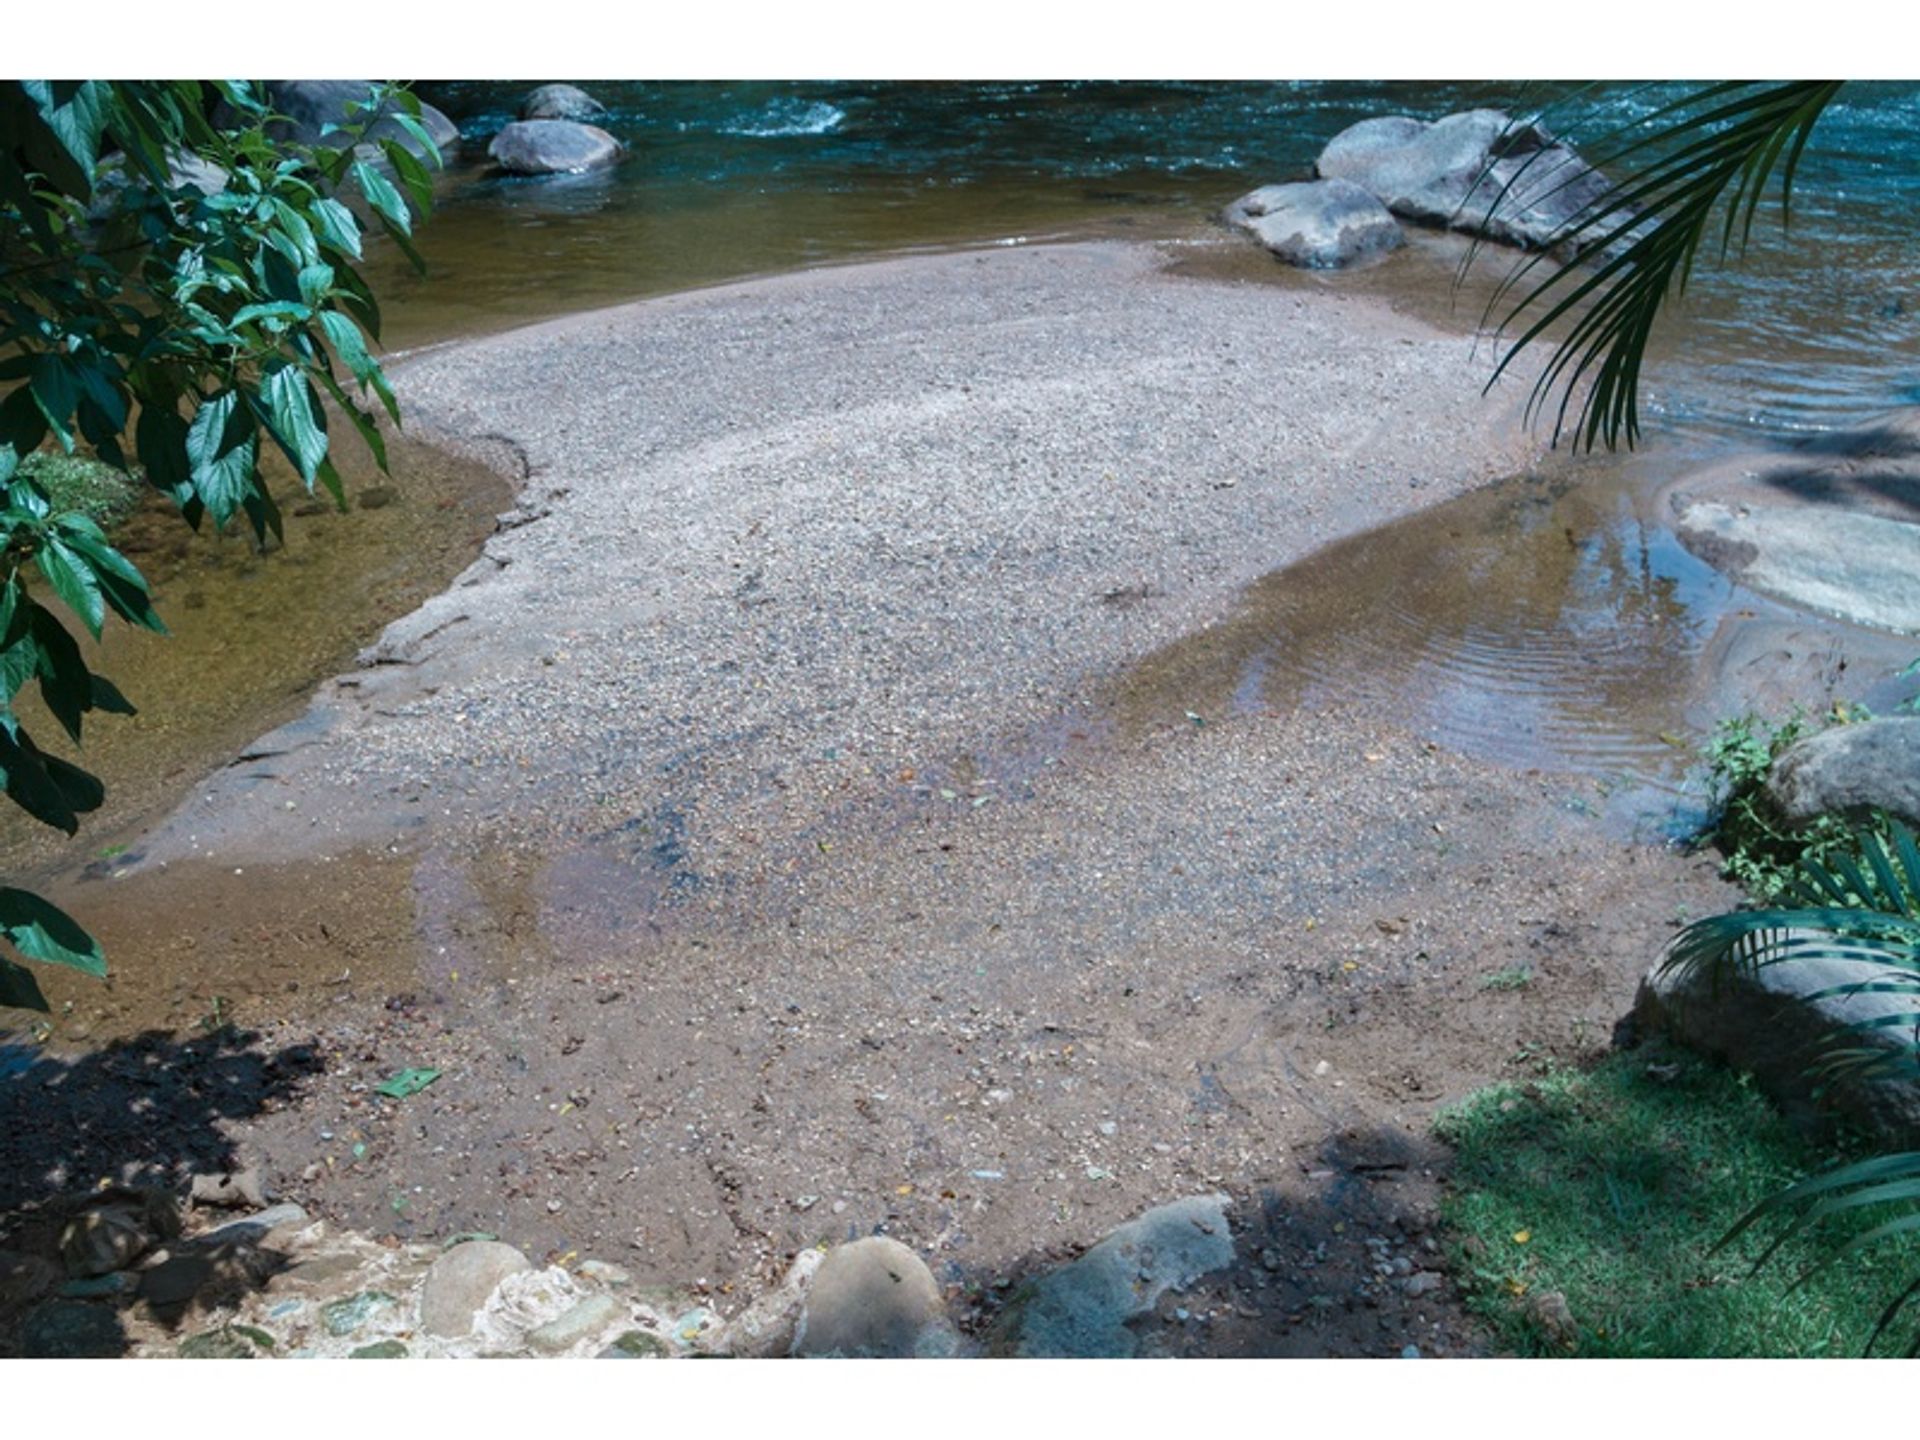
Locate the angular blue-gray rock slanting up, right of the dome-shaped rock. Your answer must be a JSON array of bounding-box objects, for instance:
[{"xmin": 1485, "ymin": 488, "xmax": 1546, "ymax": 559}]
[{"xmin": 995, "ymin": 1194, "xmax": 1233, "ymax": 1357}]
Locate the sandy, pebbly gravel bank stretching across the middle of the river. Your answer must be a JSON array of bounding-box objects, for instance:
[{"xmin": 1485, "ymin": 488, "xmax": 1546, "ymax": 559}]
[{"xmin": 0, "ymin": 244, "xmax": 1724, "ymax": 1354}]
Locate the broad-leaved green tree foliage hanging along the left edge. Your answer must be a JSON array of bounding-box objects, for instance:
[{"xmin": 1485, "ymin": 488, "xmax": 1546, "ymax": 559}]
[{"xmin": 0, "ymin": 81, "xmax": 440, "ymax": 1008}]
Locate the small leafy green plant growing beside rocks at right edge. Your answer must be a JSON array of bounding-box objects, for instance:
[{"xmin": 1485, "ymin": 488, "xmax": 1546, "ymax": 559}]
[{"xmin": 1703, "ymin": 705, "xmax": 1870, "ymax": 904}]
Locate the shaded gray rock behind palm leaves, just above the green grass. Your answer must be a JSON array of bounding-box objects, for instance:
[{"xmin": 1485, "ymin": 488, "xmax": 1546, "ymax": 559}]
[{"xmin": 1634, "ymin": 958, "xmax": 1920, "ymax": 1146}]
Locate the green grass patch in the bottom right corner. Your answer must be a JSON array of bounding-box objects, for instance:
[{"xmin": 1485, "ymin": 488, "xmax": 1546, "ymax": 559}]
[{"xmin": 1436, "ymin": 1046, "xmax": 1920, "ymax": 1357}]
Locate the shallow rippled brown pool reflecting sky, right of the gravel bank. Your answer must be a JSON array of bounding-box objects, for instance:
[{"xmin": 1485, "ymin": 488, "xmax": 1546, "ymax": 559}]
[{"xmin": 1116, "ymin": 478, "xmax": 1736, "ymax": 783}]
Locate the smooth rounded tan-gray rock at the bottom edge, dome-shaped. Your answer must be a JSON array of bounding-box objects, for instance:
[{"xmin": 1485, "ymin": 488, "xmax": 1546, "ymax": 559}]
[{"xmin": 793, "ymin": 1235, "xmax": 954, "ymax": 1357}]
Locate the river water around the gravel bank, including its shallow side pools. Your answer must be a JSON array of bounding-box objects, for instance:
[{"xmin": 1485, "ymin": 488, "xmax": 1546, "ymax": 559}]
[{"xmin": 15, "ymin": 81, "xmax": 1920, "ymax": 879}]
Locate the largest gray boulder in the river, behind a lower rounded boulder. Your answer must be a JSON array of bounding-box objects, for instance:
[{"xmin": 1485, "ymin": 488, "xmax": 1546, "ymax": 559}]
[{"xmin": 1313, "ymin": 109, "xmax": 1607, "ymax": 250}]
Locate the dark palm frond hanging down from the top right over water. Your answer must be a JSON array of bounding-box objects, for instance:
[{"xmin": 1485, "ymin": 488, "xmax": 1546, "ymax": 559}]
[{"xmin": 1488, "ymin": 81, "xmax": 1839, "ymax": 449}]
